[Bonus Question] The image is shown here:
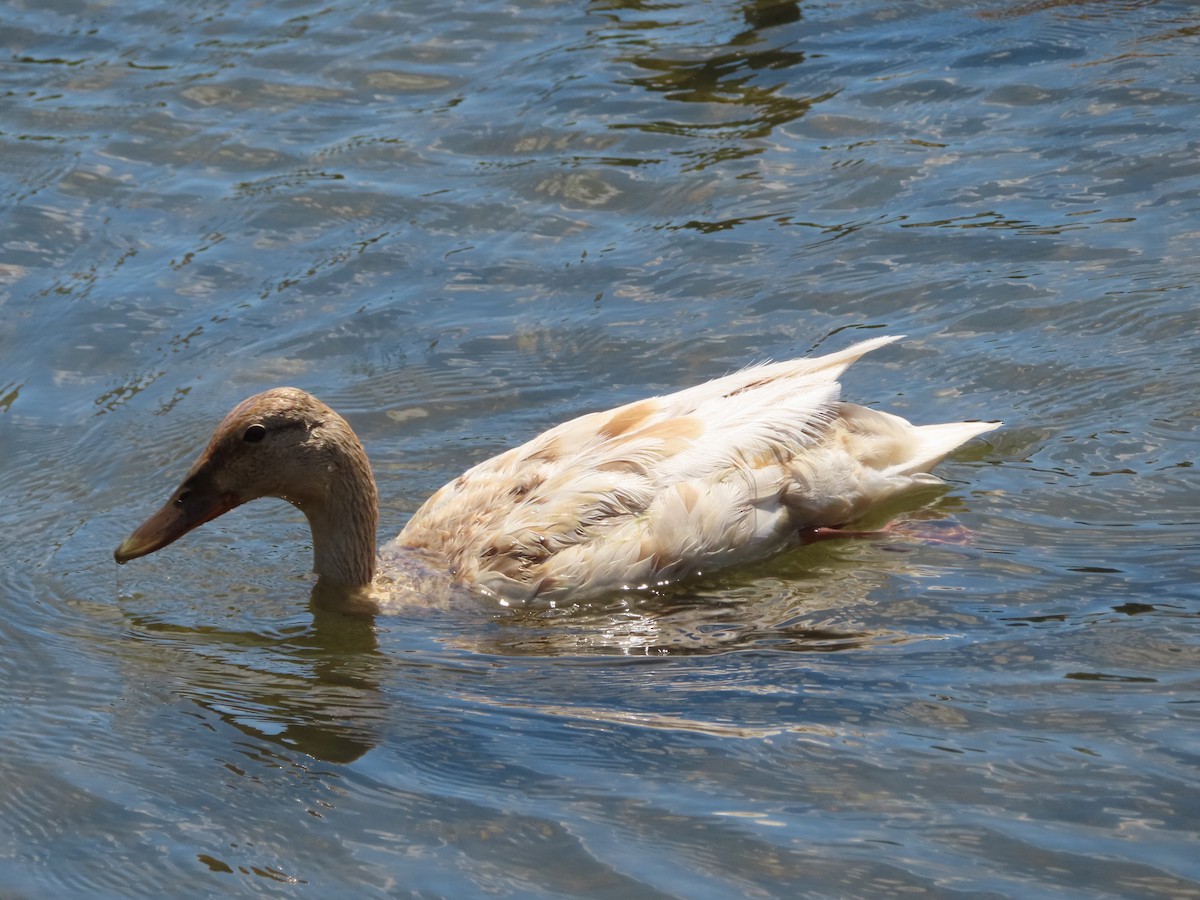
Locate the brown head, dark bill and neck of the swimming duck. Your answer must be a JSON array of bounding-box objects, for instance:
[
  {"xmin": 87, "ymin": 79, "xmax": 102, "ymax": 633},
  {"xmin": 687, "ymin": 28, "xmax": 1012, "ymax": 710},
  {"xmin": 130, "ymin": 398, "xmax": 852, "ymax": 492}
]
[{"xmin": 113, "ymin": 388, "xmax": 378, "ymax": 584}]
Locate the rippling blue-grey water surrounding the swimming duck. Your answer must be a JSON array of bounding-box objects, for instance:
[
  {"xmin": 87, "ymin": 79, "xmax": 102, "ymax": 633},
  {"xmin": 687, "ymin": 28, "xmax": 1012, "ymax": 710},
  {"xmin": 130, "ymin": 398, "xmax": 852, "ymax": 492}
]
[{"xmin": 0, "ymin": 0, "xmax": 1200, "ymax": 898}]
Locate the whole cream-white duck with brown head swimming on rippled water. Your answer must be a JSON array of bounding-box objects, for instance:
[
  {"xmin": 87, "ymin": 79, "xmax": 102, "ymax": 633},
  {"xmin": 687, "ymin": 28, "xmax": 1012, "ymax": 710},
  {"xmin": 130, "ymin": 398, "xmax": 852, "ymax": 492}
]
[{"xmin": 114, "ymin": 336, "xmax": 1001, "ymax": 607}]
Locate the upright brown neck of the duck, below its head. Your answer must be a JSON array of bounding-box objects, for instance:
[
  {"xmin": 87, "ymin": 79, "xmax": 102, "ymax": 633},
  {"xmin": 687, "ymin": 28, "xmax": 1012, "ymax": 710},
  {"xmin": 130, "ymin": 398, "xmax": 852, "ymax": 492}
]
[{"xmin": 301, "ymin": 451, "xmax": 379, "ymax": 587}]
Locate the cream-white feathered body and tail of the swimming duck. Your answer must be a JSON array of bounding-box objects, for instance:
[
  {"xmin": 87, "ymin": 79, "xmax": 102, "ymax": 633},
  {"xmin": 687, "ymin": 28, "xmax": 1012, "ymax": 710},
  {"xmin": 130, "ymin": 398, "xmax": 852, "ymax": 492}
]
[{"xmin": 396, "ymin": 337, "xmax": 995, "ymax": 602}]
